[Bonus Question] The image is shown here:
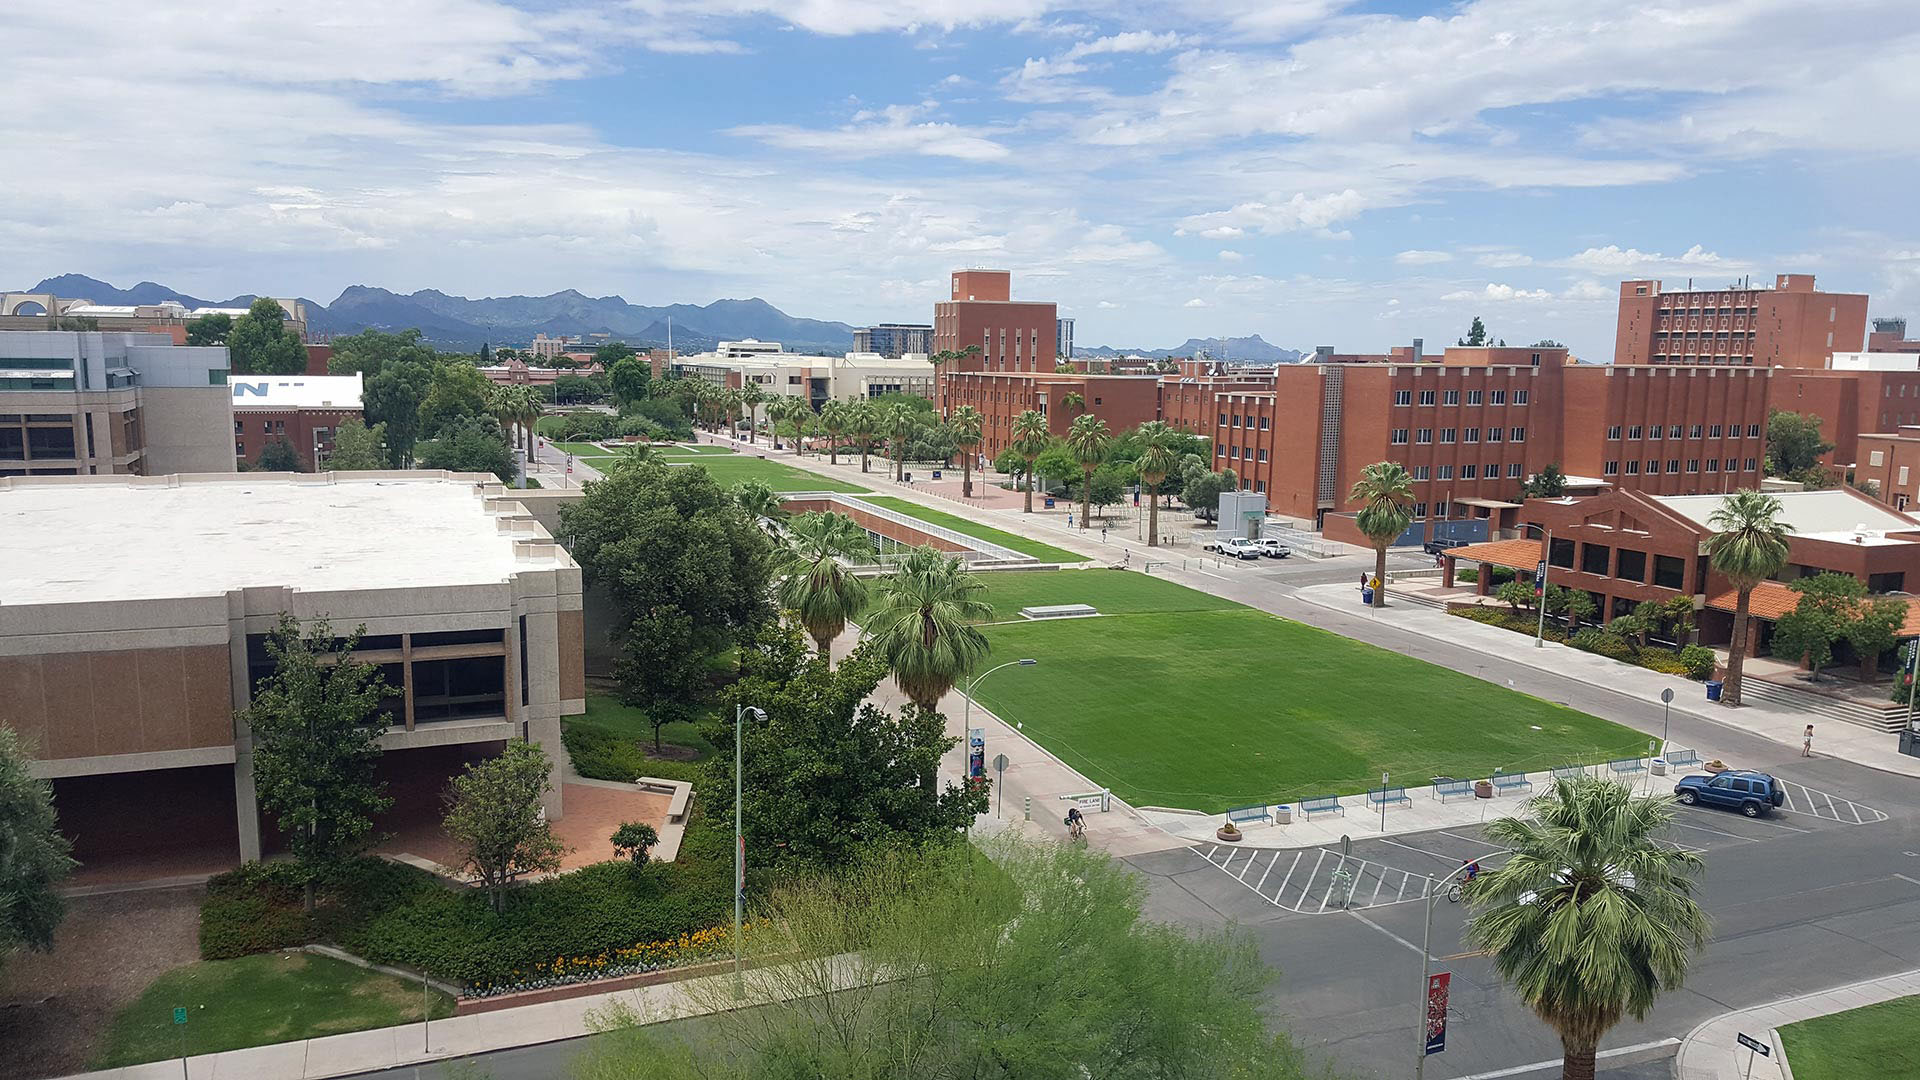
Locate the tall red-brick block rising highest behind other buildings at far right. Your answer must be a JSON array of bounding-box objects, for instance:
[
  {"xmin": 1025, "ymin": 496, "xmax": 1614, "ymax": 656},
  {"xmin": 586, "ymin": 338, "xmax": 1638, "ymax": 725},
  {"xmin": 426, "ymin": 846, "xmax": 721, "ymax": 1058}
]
[{"xmin": 1613, "ymin": 273, "xmax": 1866, "ymax": 367}]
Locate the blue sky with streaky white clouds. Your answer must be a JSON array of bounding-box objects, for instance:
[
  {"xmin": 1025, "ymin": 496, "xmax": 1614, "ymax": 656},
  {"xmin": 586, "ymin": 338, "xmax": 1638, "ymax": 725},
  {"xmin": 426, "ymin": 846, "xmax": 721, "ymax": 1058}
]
[{"xmin": 0, "ymin": 0, "xmax": 1920, "ymax": 359}]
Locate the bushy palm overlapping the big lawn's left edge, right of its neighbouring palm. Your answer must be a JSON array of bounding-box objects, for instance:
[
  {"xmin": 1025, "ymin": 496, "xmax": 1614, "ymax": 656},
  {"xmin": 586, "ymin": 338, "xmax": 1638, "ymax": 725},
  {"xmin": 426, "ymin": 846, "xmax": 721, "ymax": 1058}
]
[{"xmin": 866, "ymin": 548, "xmax": 993, "ymax": 711}]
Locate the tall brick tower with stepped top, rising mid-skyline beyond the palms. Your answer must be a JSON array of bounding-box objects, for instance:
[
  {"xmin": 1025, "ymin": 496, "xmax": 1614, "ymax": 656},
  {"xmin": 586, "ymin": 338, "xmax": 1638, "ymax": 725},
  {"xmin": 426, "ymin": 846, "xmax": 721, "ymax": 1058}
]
[{"xmin": 933, "ymin": 269, "xmax": 1060, "ymax": 405}]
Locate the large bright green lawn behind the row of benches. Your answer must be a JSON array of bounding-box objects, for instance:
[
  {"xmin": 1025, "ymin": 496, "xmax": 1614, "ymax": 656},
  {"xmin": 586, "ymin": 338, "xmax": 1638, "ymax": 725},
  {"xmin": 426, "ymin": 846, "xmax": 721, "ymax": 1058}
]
[{"xmin": 979, "ymin": 571, "xmax": 1645, "ymax": 811}]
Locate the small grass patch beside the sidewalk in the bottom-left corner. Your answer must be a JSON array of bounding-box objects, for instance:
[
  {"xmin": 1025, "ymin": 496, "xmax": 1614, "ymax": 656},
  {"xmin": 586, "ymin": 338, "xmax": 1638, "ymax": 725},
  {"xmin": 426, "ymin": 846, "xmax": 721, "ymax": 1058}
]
[{"xmin": 92, "ymin": 951, "xmax": 453, "ymax": 1068}]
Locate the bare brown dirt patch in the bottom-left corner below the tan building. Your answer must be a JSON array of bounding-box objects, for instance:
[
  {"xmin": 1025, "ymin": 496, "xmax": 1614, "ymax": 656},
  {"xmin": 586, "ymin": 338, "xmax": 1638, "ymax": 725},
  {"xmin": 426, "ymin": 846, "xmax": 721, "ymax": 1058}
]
[{"xmin": 0, "ymin": 886, "xmax": 205, "ymax": 1080}]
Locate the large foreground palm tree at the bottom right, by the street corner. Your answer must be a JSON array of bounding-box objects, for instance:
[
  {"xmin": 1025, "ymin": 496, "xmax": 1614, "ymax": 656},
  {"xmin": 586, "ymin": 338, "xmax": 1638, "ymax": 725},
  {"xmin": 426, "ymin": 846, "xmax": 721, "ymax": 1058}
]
[{"xmin": 1467, "ymin": 776, "xmax": 1707, "ymax": 1080}]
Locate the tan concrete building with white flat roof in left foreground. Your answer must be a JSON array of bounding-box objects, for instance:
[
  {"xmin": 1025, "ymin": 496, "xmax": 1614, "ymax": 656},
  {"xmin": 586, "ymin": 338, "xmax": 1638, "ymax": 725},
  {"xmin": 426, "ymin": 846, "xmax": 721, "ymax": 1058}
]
[{"xmin": 0, "ymin": 466, "xmax": 586, "ymax": 871}]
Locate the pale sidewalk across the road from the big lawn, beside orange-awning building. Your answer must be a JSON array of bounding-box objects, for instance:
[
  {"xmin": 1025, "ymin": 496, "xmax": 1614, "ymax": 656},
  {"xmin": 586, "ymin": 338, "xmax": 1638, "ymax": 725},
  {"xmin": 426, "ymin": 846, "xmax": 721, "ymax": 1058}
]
[{"xmin": 1296, "ymin": 584, "xmax": 1920, "ymax": 776}]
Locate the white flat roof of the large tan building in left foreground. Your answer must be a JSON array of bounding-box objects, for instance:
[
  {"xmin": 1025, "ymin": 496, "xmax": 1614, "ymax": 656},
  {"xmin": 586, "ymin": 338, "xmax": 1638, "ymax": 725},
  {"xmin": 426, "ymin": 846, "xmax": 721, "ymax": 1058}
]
[{"xmin": 0, "ymin": 473, "xmax": 572, "ymax": 605}]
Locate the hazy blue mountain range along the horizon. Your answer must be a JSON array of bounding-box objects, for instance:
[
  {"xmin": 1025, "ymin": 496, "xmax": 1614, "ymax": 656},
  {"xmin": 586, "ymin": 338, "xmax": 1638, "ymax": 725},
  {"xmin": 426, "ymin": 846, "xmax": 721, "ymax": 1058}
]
[{"xmin": 19, "ymin": 273, "xmax": 1302, "ymax": 363}]
